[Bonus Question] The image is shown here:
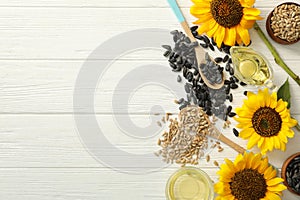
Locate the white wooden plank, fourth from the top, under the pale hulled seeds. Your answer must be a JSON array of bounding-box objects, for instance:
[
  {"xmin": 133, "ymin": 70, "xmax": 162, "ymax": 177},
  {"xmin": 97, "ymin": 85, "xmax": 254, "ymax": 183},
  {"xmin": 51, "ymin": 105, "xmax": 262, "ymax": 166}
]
[{"xmin": 0, "ymin": 114, "xmax": 300, "ymax": 170}]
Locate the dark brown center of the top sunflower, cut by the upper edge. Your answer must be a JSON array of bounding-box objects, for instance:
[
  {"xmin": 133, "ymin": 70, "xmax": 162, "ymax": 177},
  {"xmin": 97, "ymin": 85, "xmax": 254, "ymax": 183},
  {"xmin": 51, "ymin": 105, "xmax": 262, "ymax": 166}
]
[{"xmin": 210, "ymin": 0, "xmax": 243, "ymax": 28}]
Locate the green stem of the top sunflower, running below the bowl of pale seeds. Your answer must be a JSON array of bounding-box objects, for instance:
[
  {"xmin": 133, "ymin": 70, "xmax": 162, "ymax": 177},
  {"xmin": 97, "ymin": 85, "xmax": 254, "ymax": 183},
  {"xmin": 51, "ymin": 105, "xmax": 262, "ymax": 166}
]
[{"xmin": 254, "ymin": 22, "xmax": 300, "ymax": 85}]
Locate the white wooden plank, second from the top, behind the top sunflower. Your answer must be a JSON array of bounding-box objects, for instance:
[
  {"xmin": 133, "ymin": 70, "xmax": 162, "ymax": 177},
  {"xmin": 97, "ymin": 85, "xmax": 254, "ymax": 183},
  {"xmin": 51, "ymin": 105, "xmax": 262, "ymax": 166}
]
[{"xmin": 0, "ymin": 7, "xmax": 299, "ymax": 60}]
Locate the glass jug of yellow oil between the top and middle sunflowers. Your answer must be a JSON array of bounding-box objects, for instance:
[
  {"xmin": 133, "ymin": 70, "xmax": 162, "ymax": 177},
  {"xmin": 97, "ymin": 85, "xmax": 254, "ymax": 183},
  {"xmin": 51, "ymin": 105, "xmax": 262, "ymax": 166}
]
[{"xmin": 230, "ymin": 46, "xmax": 277, "ymax": 91}]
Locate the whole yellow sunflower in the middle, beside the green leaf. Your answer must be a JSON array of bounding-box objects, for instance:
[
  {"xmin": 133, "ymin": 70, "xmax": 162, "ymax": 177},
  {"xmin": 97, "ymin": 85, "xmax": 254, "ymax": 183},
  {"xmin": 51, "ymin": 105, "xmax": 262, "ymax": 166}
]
[{"xmin": 234, "ymin": 88, "xmax": 297, "ymax": 154}]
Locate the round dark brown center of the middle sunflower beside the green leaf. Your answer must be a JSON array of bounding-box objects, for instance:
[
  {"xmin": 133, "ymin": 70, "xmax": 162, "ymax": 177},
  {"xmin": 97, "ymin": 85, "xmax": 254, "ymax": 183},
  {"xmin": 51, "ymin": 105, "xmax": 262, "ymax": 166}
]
[{"xmin": 252, "ymin": 107, "xmax": 282, "ymax": 137}]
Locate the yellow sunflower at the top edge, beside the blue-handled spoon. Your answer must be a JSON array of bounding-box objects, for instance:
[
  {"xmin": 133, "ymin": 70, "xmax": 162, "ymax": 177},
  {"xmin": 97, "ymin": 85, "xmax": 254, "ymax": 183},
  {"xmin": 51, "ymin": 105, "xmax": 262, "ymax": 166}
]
[{"xmin": 190, "ymin": 0, "xmax": 262, "ymax": 47}]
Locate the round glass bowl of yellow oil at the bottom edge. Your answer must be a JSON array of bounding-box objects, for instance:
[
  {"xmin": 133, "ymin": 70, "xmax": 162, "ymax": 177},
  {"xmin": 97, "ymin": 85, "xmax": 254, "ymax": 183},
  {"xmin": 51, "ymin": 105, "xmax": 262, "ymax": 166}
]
[{"xmin": 166, "ymin": 167, "xmax": 214, "ymax": 200}]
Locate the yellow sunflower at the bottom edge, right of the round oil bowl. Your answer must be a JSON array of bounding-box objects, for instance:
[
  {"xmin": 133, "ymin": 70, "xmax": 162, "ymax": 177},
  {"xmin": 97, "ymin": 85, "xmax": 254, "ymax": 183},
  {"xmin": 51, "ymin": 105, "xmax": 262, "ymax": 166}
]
[{"xmin": 214, "ymin": 153, "xmax": 286, "ymax": 200}]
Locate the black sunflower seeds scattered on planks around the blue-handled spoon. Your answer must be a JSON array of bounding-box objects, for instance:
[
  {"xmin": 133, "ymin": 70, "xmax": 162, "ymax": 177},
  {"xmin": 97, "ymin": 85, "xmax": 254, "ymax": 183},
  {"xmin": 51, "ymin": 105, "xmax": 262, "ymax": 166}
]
[{"xmin": 162, "ymin": 26, "xmax": 246, "ymax": 121}]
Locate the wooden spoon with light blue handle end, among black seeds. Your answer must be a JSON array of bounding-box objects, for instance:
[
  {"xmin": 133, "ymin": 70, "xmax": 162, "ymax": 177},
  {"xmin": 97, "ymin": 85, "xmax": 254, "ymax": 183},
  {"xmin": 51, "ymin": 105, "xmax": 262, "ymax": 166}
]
[{"xmin": 168, "ymin": 0, "xmax": 225, "ymax": 89}]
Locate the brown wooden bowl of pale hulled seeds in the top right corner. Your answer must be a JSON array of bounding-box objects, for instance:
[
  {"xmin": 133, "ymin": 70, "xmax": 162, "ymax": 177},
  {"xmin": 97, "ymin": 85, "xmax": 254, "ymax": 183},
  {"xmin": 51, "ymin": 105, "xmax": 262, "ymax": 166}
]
[{"xmin": 266, "ymin": 2, "xmax": 300, "ymax": 45}]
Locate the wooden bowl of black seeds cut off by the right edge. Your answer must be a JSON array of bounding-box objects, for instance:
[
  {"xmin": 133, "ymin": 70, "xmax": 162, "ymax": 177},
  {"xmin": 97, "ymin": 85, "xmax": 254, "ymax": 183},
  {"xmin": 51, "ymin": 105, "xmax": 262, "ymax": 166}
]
[{"xmin": 281, "ymin": 152, "xmax": 300, "ymax": 196}]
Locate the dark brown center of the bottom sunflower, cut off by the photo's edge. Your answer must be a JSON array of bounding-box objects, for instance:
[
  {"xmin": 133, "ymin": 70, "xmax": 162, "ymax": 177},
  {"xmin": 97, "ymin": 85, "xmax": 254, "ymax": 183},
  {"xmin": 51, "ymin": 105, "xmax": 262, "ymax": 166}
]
[{"xmin": 230, "ymin": 169, "xmax": 267, "ymax": 200}]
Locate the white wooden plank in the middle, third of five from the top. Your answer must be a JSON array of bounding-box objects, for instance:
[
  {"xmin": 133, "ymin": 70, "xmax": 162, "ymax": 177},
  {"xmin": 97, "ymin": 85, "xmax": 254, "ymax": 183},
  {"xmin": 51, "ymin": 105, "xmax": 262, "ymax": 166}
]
[{"xmin": 0, "ymin": 60, "xmax": 300, "ymax": 114}]
